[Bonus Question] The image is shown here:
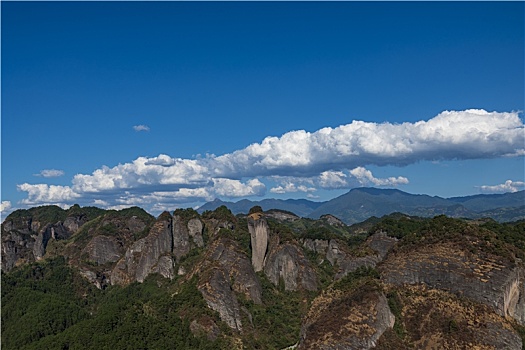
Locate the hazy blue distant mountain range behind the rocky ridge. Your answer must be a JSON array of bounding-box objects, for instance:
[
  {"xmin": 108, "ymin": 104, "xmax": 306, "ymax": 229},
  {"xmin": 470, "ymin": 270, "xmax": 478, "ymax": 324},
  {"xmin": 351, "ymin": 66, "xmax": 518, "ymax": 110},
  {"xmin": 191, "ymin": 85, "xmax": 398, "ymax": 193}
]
[{"xmin": 198, "ymin": 187, "xmax": 525, "ymax": 225}]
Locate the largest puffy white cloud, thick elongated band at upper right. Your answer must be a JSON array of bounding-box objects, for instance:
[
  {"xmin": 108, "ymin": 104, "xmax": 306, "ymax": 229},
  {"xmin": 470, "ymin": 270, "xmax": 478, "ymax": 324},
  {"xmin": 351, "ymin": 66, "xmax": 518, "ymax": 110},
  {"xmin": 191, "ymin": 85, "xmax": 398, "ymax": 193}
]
[{"xmin": 213, "ymin": 109, "xmax": 525, "ymax": 177}]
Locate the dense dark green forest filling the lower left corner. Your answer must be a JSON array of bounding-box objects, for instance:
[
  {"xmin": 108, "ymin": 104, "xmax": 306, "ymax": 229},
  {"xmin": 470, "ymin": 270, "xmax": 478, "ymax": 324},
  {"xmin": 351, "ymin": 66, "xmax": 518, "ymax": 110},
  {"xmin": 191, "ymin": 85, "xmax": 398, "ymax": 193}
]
[{"xmin": 2, "ymin": 258, "xmax": 226, "ymax": 350}]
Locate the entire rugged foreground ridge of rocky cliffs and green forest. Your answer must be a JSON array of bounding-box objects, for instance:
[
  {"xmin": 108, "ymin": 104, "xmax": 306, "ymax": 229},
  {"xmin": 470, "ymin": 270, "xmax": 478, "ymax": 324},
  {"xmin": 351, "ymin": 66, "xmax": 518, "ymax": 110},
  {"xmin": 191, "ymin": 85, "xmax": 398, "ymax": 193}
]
[{"xmin": 2, "ymin": 206, "xmax": 525, "ymax": 349}]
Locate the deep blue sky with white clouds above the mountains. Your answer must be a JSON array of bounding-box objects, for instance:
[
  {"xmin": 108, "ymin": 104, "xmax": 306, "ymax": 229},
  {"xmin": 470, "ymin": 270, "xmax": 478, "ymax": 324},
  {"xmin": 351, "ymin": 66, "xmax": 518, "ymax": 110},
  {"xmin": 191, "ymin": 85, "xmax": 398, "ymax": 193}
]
[{"xmin": 1, "ymin": 1, "xmax": 525, "ymax": 215}]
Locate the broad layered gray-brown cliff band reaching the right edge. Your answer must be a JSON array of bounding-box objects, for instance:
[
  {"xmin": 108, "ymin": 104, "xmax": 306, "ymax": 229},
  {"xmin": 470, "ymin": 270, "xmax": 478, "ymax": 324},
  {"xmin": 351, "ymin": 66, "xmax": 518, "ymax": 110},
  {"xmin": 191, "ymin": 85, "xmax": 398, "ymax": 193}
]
[{"xmin": 381, "ymin": 244, "xmax": 525, "ymax": 324}]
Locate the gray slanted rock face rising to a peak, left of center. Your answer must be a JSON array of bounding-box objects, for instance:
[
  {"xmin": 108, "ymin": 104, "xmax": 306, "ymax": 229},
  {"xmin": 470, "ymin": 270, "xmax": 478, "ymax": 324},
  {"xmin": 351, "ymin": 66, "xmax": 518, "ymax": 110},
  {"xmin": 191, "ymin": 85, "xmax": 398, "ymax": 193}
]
[{"xmin": 111, "ymin": 212, "xmax": 173, "ymax": 284}]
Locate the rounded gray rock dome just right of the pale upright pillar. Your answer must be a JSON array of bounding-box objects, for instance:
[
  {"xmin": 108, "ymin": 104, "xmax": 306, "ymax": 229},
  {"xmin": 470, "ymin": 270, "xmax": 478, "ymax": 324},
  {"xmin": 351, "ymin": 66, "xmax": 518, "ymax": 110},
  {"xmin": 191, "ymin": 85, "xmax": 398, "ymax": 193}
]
[{"xmin": 264, "ymin": 243, "xmax": 318, "ymax": 291}]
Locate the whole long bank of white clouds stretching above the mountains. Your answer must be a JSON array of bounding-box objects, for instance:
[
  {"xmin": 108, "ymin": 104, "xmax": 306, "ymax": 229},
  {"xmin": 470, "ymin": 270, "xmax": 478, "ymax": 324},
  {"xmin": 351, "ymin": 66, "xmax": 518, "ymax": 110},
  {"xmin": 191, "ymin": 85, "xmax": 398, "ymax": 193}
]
[{"xmin": 18, "ymin": 109, "xmax": 525, "ymax": 212}]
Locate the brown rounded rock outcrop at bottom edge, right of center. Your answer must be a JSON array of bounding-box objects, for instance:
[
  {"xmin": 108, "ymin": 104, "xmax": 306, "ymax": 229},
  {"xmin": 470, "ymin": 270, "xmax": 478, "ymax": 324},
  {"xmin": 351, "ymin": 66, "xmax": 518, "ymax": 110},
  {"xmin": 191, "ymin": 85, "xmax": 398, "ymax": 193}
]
[{"xmin": 298, "ymin": 291, "xmax": 395, "ymax": 350}]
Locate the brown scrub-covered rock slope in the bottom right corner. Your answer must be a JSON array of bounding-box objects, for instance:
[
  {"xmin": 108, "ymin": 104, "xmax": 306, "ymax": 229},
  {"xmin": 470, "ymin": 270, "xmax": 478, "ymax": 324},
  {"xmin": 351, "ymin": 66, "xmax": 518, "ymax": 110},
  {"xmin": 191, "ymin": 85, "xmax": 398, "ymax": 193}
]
[{"xmin": 376, "ymin": 285, "xmax": 522, "ymax": 350}]
